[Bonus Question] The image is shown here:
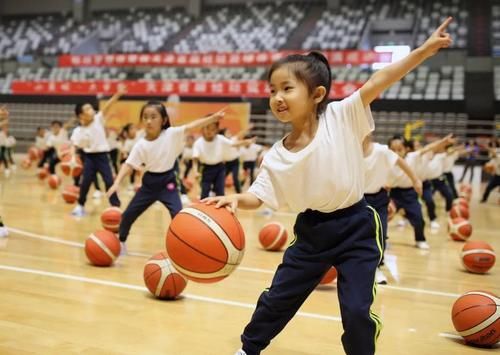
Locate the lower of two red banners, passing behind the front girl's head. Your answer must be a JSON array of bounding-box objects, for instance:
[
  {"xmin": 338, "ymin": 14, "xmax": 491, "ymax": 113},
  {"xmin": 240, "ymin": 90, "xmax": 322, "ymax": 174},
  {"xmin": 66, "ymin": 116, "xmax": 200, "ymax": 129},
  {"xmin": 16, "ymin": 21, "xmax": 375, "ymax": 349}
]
[{"xmin": 11, "ymin": 80, "xmax": 363, "ymax": 99}]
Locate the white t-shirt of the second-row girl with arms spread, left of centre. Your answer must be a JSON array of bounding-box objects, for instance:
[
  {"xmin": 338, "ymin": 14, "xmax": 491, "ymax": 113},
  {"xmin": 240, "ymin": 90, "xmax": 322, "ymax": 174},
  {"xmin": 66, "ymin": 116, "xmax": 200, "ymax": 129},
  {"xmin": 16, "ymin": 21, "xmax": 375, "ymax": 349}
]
[{"xmin": 125, "ymin": 126, "xmax": 185, "ymax": 173}]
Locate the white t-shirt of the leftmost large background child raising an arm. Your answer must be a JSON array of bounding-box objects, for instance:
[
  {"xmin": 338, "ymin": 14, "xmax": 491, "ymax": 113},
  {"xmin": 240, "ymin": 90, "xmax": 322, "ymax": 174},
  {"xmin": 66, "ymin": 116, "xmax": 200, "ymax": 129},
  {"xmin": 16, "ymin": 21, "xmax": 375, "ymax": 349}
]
[{"xmin": 75, "ymin": 112, "xmax": 109, "ymax": 153}]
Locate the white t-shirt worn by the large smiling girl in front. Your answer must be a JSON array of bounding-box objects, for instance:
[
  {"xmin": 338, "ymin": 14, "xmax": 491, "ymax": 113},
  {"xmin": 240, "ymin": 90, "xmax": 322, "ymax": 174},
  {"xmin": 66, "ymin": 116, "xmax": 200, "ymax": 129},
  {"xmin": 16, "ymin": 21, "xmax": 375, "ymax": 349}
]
[{"xmin": 248, "ymin": 91, "xmax": 374, "ymax": 213}]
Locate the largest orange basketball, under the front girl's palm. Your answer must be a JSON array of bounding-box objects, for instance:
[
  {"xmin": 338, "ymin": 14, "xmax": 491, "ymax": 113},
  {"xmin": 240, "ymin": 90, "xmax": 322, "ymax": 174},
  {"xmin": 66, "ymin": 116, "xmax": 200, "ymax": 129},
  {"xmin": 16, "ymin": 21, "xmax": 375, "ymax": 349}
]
[{"xmin": 166, "ymin": 203, "xmax": 245, "ymax": 282}]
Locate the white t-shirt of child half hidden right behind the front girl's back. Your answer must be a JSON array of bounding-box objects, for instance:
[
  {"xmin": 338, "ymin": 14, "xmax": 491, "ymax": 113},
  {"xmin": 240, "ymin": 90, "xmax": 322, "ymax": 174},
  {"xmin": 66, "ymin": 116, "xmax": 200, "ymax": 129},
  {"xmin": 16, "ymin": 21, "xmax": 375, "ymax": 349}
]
[{"xmin": 365, "ymin": 143, "xmax": 399, "ymax": 194}]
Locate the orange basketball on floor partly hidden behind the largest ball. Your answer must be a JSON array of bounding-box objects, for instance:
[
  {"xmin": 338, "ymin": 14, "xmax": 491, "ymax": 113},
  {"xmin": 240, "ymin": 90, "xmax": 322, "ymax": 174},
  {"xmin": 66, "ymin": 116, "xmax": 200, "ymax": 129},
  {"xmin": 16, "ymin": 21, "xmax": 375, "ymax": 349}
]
[{"xmin": 144, "ymin": 252, "xmax": 187, "ymax": 299}]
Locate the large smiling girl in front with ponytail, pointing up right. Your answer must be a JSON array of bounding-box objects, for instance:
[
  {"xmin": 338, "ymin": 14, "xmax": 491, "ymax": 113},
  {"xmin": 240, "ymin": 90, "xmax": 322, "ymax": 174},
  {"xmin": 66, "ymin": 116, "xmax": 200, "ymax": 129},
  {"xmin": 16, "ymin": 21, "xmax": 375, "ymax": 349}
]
[{"xmin": 204, "ymin": 18, "xmax": 451, "ymax": 355}]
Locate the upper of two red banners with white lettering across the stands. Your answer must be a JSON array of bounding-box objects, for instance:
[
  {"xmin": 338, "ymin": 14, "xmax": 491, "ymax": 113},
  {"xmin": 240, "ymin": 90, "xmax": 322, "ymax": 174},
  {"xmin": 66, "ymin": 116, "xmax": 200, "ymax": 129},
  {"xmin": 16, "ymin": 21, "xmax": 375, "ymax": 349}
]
[{"xmin": 59, "ymin": 50, "xmax": 392, "ymax": 67}]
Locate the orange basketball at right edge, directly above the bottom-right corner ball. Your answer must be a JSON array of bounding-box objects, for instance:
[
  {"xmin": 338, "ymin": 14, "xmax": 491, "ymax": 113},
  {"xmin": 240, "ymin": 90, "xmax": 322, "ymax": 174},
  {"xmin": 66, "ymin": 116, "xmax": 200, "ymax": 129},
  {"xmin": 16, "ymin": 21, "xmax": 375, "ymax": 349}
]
[{"xmin": 462, "ymin": 241, "xmax": 496, "ymax": 274}]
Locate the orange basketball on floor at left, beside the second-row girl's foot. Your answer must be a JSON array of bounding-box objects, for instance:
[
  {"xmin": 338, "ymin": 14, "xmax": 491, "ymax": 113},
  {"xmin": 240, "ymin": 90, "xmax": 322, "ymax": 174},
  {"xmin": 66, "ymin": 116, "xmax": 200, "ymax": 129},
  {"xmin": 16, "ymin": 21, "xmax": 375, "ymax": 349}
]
[{"xmin": 85, "ymin": 230, "xmax": 120, "ymax": 266}]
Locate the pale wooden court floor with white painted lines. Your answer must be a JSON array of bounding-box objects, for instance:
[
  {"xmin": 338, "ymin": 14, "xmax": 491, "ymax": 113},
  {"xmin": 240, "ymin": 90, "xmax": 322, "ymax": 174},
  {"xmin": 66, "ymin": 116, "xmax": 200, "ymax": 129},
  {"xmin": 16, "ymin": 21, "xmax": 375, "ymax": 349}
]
[{"xmin": 0, "ymin": 169, "xmax": 500, "ymax": 355}]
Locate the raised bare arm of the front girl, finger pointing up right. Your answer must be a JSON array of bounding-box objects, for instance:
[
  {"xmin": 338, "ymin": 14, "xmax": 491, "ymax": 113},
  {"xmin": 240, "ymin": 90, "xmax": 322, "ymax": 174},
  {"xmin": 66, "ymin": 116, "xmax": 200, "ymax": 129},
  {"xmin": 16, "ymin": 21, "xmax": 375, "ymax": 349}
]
[{"xmin": 360, "ymin": 17, "xmax": 453, "ymax": 106}]
